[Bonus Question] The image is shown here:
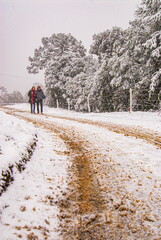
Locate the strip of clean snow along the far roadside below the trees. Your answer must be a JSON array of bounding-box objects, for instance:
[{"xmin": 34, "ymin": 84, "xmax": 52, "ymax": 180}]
[{"xmin": 10, "ymin": 104, "xmax": 161, "ymax": 133}]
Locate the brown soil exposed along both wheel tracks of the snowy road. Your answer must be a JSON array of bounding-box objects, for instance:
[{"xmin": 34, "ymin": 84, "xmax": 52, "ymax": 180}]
[{"xmin": 0, "ymin": 108, "xmax": 161, "ymax": 240}]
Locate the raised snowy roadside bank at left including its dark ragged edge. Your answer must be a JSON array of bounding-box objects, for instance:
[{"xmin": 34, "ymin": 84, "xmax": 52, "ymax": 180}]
[{"xmin": 0, "ymin": 111, "xmax": 37, "ymax": 194}]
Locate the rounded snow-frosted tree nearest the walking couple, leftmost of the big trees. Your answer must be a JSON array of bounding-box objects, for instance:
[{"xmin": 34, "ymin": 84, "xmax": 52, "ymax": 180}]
[{"xmin": 27, "ymin": 33, "xmax": 86, "ymax": 107}]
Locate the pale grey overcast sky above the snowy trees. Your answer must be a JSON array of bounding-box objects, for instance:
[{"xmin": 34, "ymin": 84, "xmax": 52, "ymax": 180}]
[{"xmin": 0, "ymin": 0, "xmax": 141, "ymax": 94}]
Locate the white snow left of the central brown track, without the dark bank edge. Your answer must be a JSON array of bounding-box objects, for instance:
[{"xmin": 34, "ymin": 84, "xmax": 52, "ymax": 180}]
[{"xmin": 0, "ymin": 107, "xmax": 71, "ymax": 240}]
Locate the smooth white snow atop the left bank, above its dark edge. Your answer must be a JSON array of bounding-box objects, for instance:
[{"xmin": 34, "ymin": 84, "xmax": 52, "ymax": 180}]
[{"xmin": 0, "ymin": 111, "xmax": 36, "ymax": 171}]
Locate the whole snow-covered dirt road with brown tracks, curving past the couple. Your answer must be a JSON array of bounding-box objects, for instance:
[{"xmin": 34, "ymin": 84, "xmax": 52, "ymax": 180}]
[{"xmin": 0, "ymin": 107, "xmax": 161, "ymax": 240}]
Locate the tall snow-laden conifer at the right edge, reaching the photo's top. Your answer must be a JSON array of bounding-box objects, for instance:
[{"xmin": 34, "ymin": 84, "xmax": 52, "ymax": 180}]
[{"xmin": 136, "ymin": 0, "xmax": 161, "ymax": 109}]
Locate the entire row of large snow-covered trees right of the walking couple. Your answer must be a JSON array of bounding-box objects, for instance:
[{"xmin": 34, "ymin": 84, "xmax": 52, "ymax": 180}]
[{"xmin": 27, "ymin": 0, "xmax": 161, "ymax": 112}]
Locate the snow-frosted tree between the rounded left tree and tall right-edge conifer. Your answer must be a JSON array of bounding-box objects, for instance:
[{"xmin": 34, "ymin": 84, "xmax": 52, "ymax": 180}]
[{"xmin": 90, "ymin": 27, "xmax": 129, "ymax": 111}]
